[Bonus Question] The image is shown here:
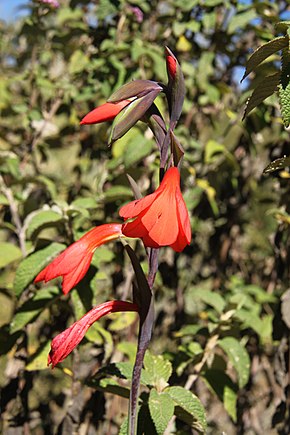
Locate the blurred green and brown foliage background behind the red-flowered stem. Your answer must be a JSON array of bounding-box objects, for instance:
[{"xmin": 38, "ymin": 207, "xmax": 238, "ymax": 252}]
[{"xmin": 0, "ymin": 0, "xmax": 290, "ymax": 434}]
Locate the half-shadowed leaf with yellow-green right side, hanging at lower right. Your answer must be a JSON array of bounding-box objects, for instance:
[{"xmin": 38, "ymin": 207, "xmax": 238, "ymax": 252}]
[{"xmin": 203, "ymin": 369, "xmax": 237, "ymax": 421}]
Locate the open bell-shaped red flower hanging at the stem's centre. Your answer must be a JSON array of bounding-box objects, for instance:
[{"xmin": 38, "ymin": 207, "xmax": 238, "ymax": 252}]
[{"xmin": 119, "ymin": 167, "xmax": 191, "ymax": 252}]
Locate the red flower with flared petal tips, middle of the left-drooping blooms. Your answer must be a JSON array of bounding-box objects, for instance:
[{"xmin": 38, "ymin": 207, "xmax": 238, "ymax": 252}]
[{"xmin": 34, "ymin": 224, "xmax": 122, "ymax": 294}]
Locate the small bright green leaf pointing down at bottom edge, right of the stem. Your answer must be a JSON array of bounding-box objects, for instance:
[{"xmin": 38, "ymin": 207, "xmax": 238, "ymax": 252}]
[{"xmin": 148, "ymin": 388, "xmax": 174, "ymax": 435}]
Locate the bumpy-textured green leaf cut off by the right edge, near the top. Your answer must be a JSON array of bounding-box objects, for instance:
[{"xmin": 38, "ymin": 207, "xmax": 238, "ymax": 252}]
[{"xmin": 278, "ymin": 49, "xmax": 290, "ymax": 127}]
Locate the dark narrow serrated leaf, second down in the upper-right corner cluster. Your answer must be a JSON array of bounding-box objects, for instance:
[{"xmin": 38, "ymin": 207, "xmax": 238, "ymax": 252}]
[{"xmin": 243, "ymin": 73, "xmax": 280, "ymax": 119}]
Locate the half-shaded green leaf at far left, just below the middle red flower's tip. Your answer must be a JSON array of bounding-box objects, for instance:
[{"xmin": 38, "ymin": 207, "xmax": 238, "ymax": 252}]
[{"xmin": 10, "ymin": 287, "xmax": 59, "ymax": 334}]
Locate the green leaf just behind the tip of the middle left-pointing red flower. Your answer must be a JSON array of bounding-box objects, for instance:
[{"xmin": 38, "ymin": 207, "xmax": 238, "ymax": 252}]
[{"xmin": 14, "ymin": 243, "xmax": 66, "ymax": 296}]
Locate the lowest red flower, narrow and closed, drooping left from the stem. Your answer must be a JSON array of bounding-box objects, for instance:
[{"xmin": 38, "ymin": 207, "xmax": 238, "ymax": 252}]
[{"xmin": 47, "ymin": 301, "xmax": 139, "ymax": 368}]
